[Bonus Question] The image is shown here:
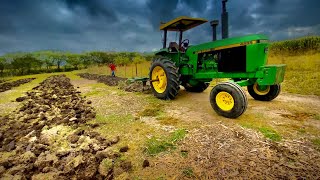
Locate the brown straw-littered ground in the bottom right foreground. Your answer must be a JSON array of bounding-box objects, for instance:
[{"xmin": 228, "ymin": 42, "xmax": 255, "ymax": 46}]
[{"xmin": 181, "ymin": 124, "xmax": 320, "ymax": 179}]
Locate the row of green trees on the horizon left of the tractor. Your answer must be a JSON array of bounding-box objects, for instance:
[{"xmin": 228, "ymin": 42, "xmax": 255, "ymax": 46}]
[{"xmin": 0, "ymin": 51, "xmax": 153, "ymax": 76}]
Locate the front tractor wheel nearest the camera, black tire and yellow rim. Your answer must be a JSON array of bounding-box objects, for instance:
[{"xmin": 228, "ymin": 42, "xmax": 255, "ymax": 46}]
[{"xmin": 210, "ymin": 82, "xmax": 248, "ymax": 118}]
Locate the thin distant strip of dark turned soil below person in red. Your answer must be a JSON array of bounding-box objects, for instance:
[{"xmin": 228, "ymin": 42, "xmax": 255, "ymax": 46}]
[{"xmin": 77, "ymin": 73, "xmax": 126, "ymax": 86}]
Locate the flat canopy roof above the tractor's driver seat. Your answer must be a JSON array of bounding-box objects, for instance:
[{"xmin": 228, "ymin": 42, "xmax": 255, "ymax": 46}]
[{"xmin": 160, "ymin": 16, "xmax": 208, "ymax": 31}]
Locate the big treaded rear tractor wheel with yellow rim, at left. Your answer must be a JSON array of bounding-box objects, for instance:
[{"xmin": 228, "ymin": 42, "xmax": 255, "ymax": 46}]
[{"xmin": 149, "ymin": 57, "xmax": 180, "ymax": 100}]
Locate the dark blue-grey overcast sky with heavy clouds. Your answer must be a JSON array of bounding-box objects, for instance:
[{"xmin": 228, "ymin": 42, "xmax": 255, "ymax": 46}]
[{"xmin": 0, "ymin": 0, "xmax": 320, "ymax": 55}]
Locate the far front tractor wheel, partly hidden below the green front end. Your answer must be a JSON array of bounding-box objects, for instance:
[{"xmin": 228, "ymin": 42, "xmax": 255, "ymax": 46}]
[{"xmin": 247, "ymin": 83, "xmax": 281, "ymax": 101}]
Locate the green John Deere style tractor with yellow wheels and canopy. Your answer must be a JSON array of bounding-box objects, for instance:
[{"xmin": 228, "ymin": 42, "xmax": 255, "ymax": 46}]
[{"xmin": 149, "ymin": 16, "xmax": 286, "ymax": 118}]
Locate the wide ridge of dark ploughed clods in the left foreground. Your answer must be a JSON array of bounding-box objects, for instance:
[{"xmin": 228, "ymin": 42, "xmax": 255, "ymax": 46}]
[{"xmin": 0, "ymin": 75, "xmax": 126, "ymax": 179}]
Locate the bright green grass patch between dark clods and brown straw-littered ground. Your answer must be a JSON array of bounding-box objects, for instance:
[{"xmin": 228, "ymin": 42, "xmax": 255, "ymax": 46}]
[{"xmin": 146, "ymin": 129, "xmax": 187, "ymax": 156}]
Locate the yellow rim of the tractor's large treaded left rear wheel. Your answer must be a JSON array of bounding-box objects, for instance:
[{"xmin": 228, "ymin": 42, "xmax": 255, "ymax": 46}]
[{"xmin": 151, "ymin": 66, "xmax": 167, "ymax": 93}]
